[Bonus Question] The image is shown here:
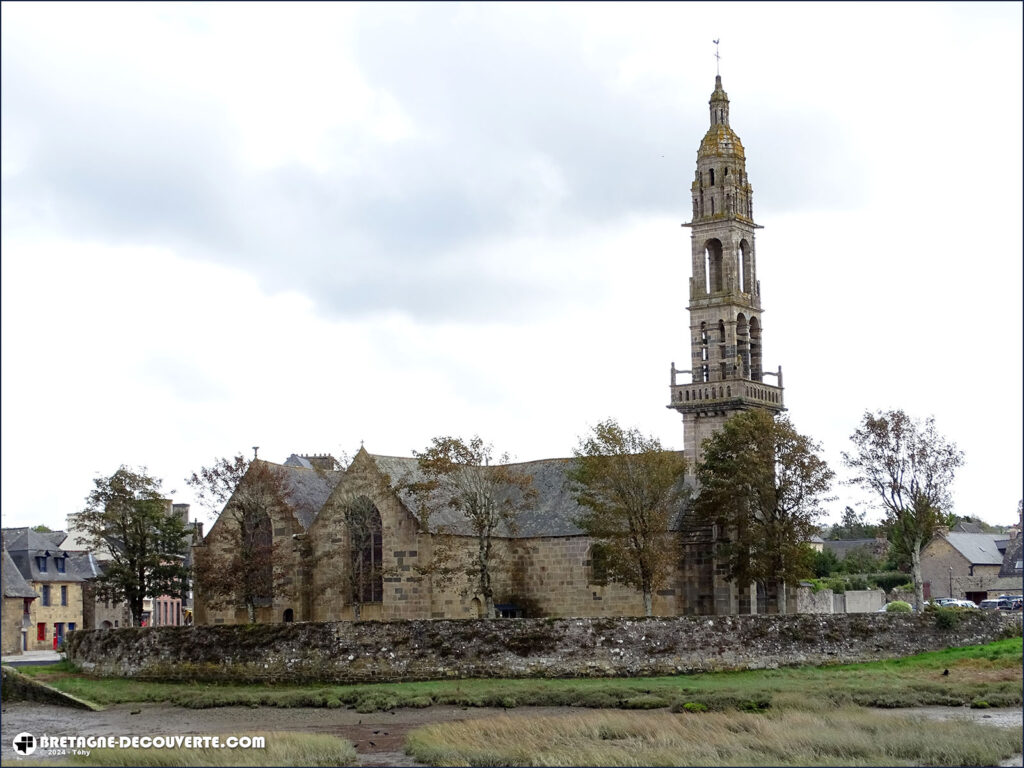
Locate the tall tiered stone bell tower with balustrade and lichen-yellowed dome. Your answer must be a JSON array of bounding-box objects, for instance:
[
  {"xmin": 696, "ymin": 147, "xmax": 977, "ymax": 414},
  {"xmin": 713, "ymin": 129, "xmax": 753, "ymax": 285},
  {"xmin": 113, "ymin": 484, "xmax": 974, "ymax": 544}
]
[{"xmin": 668, "ymin": 76, "xmax": 785, "ymax": 476}]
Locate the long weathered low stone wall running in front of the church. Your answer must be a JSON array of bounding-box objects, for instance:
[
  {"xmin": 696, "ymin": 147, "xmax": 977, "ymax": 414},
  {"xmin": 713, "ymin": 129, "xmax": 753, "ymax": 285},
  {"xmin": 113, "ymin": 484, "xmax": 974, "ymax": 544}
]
[{"xmin": 66, "ymin": 611, "xmax": 1021, "ymax": 683}]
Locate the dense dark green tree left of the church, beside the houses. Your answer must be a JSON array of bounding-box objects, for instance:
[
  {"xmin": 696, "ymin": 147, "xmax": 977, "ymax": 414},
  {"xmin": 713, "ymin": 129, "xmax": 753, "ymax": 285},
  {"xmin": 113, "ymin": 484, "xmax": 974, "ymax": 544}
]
[{"xmin": 76, "ymin": 466, "xmax": 190, "ymax": 626}]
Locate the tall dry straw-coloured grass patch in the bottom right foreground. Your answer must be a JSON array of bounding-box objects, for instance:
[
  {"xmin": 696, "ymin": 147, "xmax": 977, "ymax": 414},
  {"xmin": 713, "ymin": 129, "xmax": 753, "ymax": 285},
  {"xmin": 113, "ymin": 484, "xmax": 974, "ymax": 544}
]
[{"xmin": 407, "ymin": 708, "xmax": 1022, "ymax": 766}]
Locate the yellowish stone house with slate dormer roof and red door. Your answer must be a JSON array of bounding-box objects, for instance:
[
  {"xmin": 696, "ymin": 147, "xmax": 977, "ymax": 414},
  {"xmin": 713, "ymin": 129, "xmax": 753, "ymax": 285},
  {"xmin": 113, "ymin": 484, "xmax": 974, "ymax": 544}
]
[{"xmin": 3, "ymin": 528, "xmax": 86, "ymax": 650}]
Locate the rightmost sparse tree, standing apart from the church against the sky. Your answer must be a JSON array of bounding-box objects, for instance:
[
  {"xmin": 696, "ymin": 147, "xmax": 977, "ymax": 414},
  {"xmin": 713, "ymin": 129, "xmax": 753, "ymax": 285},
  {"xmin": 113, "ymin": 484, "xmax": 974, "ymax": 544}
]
[{"xmin": 843, "ymin": 411, "xmax": 964, "ymax": 610}]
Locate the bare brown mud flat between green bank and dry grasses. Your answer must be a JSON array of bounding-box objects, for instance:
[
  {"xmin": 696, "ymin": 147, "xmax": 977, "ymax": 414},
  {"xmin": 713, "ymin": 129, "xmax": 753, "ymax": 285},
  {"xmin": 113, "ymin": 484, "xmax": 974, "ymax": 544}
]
[{"xmin": 0, "ymin": 701, "xmax": 1024, "ymax": 768}]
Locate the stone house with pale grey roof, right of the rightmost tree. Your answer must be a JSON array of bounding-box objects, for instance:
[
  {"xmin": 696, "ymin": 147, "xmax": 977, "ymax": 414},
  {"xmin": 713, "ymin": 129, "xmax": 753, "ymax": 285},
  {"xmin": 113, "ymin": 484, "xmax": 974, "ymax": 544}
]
[{"xmin": 921, "ymin": 531, "xmax": 1022, "ymax": 603}]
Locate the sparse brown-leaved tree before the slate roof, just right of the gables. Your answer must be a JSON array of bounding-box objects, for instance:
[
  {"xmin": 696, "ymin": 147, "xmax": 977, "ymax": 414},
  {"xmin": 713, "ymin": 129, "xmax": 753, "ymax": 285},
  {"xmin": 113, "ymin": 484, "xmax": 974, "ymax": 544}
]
[{"xmin": 413, "ymin": 435, "xmax": 537, "ymax": 618}]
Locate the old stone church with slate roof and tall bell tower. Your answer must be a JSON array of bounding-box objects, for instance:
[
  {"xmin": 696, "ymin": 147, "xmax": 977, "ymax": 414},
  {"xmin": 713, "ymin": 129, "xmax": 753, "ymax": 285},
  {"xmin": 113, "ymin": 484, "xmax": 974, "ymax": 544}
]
[{"xmin": 195, "ymin": 76, "xmax": 784, "ymax": 624}]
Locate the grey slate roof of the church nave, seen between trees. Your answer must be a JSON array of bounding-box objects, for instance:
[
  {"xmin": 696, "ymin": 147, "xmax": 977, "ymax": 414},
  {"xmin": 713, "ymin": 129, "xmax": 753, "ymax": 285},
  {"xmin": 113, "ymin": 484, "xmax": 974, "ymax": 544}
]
[{"xmin": 370, "ymin": 454, "xmax": 682, "ymax": 539}]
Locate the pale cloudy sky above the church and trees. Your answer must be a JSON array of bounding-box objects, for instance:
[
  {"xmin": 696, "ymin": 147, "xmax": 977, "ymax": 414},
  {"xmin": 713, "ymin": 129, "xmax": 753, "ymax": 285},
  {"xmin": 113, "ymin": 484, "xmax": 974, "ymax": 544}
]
[{"xmin": 0, "ymin": 2, "xmax": 1024, "ymax": 528}]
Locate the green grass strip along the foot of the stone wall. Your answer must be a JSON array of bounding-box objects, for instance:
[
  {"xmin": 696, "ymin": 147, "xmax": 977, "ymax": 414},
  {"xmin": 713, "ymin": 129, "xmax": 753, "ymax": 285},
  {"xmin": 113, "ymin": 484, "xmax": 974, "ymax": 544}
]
[{"xmin": 20, "ymin": 637, "xmax": 1024, "ymax": 712}]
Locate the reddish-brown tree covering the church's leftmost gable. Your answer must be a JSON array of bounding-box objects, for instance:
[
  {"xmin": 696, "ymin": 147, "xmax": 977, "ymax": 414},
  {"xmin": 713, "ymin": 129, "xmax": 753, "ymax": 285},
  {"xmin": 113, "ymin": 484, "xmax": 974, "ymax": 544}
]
[{"xmin": 185, "ymin": 455, "xmax": 291, "ymax": 624}]
